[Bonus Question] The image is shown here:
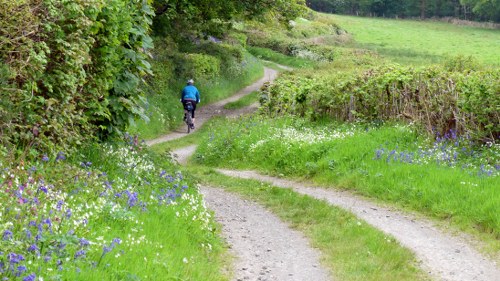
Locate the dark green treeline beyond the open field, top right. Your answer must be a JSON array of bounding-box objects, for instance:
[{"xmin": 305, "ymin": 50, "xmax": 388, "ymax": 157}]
[{"xmin": 307, "ymin": 0, "xmax": 500, "ymax": 22}]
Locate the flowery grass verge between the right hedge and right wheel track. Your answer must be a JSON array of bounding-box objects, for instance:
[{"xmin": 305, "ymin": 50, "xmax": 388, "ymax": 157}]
[{"xmin": 194, "ymin": 115, "xmax": 500, "ymax": 255}]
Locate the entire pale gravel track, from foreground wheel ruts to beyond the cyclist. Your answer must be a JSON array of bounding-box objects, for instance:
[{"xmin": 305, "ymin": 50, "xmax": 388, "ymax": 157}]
[{"xmin": 147, "ymin": 68, "xmax": 500, "ymax": 281}]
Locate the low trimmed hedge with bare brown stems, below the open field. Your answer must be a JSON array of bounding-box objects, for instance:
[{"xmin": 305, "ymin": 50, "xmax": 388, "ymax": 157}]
[{"xmin": 263, "ymin": 65, "xmax": 500, "ymax": 140}]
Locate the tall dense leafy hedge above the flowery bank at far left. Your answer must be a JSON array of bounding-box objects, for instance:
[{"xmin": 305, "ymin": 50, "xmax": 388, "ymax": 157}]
[{"xmin": 0, "ymin": 0, "xmax": 153, "ymax": 154}]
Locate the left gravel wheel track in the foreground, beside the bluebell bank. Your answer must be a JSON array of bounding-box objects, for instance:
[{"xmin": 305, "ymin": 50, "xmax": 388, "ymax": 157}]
[{"xmin": 201, "ymin": 187, "xmax": 331, "ymax": 281}]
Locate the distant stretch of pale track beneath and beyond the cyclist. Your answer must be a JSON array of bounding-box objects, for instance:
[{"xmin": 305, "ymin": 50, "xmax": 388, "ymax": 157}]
[{"xmin": 146, "ymin": 67, "xmax": 278, "ymax": 146}]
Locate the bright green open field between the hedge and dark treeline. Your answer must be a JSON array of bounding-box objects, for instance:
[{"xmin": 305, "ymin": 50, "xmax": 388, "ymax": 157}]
[{"xmin": 328, "ymin": 15, "xmax": 500, "ymax": 67}]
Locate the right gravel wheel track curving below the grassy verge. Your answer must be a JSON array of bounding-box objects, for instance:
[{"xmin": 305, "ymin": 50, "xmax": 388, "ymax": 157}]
[{"xmin": 219, "ymin": 169, "xmax": 500, "ymax": 281}]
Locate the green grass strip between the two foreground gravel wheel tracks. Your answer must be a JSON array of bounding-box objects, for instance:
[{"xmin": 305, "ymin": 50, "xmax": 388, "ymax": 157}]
[{"xmin": 188, "ymin": 166, "xmax": 428, "ymax": 280}]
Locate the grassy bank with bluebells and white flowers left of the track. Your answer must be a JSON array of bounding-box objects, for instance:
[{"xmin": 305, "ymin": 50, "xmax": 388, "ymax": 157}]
[{"xmin": 0, "ymin": 140, "xmax": 228, "ymax": 280}]
